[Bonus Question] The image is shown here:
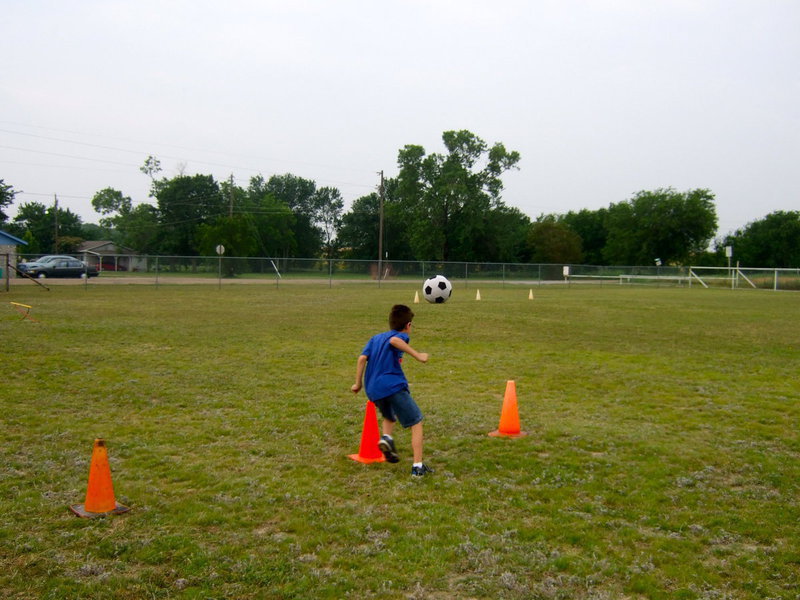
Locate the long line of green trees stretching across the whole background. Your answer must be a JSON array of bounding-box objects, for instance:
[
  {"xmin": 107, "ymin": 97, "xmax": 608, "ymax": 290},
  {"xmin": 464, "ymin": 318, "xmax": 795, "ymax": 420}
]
[{"xmin": 0, "ymin": 130, "xmax": 800, "ymax": 268}]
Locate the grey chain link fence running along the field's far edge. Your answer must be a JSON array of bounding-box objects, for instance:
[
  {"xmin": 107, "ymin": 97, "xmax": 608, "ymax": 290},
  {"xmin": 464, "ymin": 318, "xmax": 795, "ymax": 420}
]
[{"xmin": 0, "ymin": 254, "xmax": 800, "ymax": 290}]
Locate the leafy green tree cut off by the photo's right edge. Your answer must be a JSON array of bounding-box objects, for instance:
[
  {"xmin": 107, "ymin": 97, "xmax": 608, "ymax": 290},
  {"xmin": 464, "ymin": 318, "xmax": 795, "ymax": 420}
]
[{"xmin": 717, "ymin": 210, "xmax": 800, "ymax": 268}]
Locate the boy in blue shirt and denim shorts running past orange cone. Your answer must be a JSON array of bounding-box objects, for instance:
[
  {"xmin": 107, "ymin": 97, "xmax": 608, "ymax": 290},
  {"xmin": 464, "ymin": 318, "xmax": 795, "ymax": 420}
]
[{"xmin": 350, "ymin": 304, "xmax": 433, "ymax": 477}]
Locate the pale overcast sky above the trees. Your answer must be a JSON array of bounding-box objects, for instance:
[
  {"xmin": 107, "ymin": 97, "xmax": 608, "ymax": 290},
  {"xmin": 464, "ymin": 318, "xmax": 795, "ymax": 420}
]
[{"xmin": 0, "ymin": 0, "xmax": 800, "ymax": 235}]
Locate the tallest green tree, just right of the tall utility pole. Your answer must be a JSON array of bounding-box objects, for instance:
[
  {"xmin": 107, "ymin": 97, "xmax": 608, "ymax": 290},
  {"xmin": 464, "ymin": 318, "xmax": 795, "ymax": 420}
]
[{"xmin": 397, "ymin": 130, "xmax": 520, "ymax": 261}]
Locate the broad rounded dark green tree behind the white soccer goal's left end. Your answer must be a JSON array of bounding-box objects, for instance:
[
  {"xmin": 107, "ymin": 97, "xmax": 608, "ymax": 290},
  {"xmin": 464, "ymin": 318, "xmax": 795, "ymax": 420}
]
[{"xmin": 603, "ymin": 188, "xmax": 717, "ymax": 265}]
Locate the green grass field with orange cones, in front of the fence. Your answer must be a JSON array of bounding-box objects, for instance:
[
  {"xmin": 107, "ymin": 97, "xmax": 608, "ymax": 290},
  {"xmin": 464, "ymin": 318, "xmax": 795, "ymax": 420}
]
[{"xmin": 0, "ymin": 282, "xmax": 800, "ymax": 600}]
